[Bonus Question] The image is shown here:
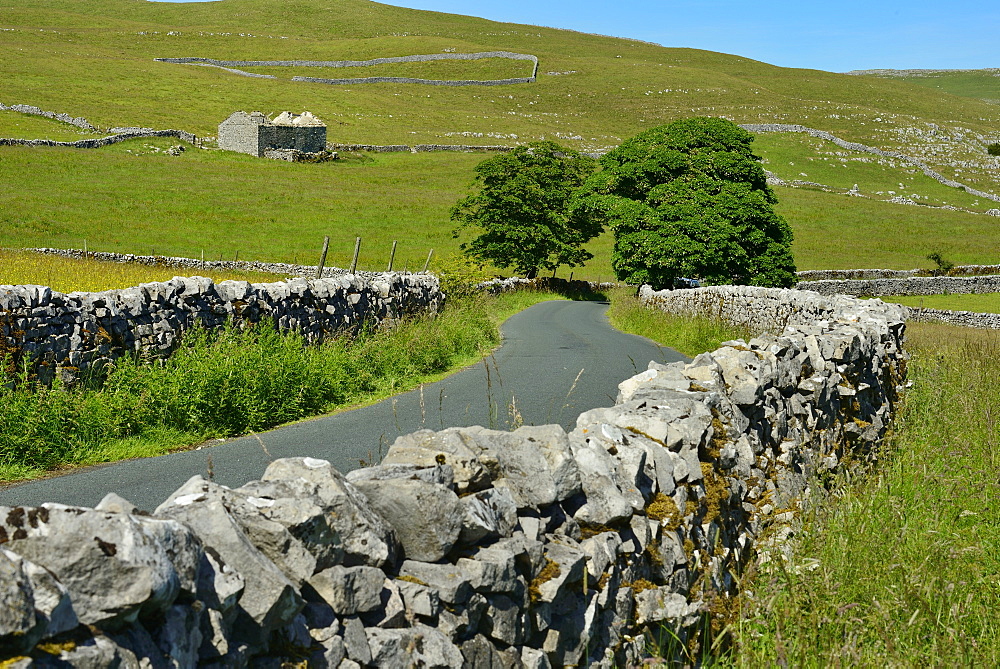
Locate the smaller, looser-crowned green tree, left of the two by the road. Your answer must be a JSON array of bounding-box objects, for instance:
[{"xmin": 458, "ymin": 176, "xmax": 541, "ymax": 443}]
[{"xmin": 451, "ymin": 142, "xmax": 602, "ymax": 278}]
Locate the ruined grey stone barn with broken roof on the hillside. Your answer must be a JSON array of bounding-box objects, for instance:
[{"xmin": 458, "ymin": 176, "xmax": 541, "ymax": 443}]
[{"xmin": 219, "ymin": 111, "xmax": 326, "ymax": 158}]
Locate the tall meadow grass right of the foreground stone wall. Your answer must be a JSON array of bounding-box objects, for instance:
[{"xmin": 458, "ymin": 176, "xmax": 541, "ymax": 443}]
[{"xmin": 732, "ymin": 324, "xmax": 1000, "ymax": 667}]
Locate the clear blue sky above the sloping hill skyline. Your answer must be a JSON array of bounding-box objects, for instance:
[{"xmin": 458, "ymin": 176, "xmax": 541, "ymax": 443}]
[{"xmin": 152, "ymin": 0, "xmax": 1000, "ymax": 72}]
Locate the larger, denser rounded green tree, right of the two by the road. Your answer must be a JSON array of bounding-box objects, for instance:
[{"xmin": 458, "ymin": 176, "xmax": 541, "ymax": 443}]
[{"xmin": 571, "ymin": 117, "xmax": 796, "ymax": 288}]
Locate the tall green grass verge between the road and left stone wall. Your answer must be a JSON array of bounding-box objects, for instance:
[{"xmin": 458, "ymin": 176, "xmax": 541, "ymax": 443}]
[{"xmin": 0, "ymin": 293, "xmax": 559, "ymax": 481}]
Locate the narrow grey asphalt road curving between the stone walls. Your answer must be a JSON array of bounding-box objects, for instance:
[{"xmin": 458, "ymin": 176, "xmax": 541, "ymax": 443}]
[{"xmin": 0, "ymin": 301, "xmax": 685, "ymax": 511}]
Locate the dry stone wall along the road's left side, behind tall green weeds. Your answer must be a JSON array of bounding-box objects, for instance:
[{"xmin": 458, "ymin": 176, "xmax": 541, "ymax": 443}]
[{"xmin": 0, "ymin": 273, "xmax": 444, "ymax": 381}]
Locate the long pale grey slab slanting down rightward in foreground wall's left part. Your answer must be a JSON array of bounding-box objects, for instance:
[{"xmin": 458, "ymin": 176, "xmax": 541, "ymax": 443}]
[{"xmin": 156, "ymin": 476, "xmax": 304, "ymax": 639}]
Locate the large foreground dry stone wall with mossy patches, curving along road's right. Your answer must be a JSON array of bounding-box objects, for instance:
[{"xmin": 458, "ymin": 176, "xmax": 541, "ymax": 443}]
[{"xmin": 0, "ymin": 287, "xmax": 906, "ymax": 669}]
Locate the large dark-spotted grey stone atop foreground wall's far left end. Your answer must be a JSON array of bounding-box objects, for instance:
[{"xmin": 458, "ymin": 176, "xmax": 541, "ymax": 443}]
[{"xmin": 0, "ymin": 504, "xmax": 180, "ymax": 627}]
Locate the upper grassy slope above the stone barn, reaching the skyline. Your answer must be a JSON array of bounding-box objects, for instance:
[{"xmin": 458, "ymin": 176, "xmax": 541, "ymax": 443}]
[{"xmin": 0, "ymin": 0, "xmax": 1000, "ymax": 172}]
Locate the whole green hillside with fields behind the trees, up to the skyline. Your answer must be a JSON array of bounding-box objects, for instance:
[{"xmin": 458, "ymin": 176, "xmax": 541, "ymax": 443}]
[{"xmin": 0, "ymin": 0, "xmax": 1000, "ymax": 276}]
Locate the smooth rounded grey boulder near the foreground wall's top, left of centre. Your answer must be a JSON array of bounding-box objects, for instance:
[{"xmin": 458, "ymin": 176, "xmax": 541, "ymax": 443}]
[{"xmin": 355, "ymin": 479, "xmax": 465, "ymax": 562}]
